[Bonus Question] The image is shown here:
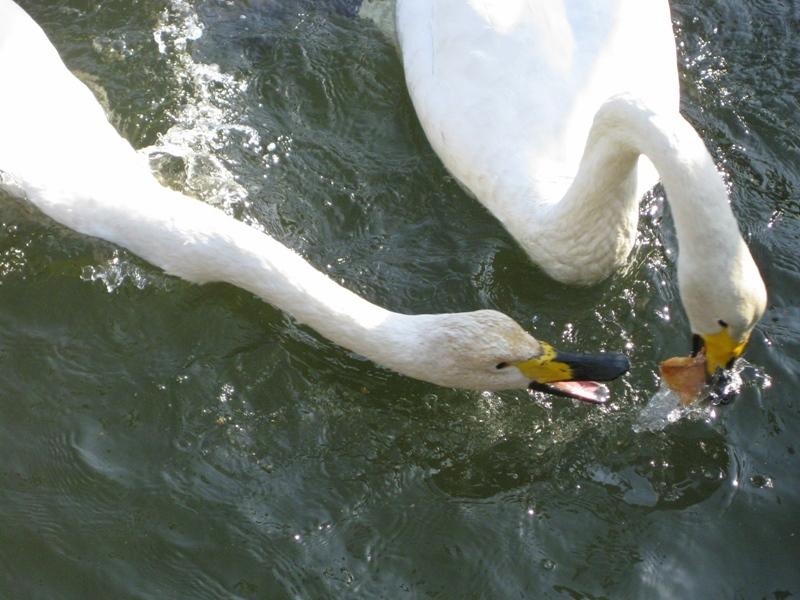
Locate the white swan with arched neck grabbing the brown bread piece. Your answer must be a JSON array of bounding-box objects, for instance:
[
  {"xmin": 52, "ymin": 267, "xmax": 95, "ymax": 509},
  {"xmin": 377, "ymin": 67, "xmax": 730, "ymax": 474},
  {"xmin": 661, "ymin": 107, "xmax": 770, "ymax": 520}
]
[{"xmin": 396, "ymin": 0, "xmax": 766, "ymax": 375}]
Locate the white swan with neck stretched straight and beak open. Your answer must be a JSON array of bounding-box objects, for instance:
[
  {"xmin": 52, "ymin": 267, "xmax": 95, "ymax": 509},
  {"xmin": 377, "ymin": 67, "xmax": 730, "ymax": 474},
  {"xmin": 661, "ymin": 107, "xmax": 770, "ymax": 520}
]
[{"xmin": 0, "ymin": 0, "xmax": 628, "ymax": 402}]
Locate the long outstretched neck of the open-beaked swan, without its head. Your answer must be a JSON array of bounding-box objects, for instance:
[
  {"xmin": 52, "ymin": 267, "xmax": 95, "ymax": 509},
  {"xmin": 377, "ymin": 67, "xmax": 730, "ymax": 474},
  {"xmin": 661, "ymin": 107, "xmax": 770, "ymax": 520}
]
[{"xmin": 21, "ymin": 171, "xmax": 444, "ymax": 379}]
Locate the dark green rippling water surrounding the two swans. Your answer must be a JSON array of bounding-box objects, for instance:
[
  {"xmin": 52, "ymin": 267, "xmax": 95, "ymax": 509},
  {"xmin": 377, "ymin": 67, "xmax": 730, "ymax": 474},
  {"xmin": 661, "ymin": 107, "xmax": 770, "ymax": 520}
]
[{"xmin": 0, "ymin": 0, "xmax": 800, "ymax": 599}]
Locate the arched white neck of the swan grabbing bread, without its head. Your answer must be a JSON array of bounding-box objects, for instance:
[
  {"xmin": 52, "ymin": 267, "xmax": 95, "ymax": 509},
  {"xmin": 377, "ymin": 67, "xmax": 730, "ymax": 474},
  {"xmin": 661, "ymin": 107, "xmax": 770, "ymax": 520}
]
[{"xmin": 510, "ymin": 96, "xmax": 742, "ymax": 283}]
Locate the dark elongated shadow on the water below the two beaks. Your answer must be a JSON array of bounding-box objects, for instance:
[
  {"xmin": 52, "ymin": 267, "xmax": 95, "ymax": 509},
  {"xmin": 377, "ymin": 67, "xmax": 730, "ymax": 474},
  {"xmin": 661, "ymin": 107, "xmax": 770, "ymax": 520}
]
[{"xmin": 432, "ymin": 424, "xmax": 730, "ymax": 511}]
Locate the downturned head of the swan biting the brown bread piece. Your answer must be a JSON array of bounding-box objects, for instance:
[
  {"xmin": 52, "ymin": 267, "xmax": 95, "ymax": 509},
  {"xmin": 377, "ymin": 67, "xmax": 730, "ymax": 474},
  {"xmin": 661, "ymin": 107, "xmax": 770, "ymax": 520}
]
[{"xmin": 678, "ymin": 239, "xmax": 767, "ymax": 378}]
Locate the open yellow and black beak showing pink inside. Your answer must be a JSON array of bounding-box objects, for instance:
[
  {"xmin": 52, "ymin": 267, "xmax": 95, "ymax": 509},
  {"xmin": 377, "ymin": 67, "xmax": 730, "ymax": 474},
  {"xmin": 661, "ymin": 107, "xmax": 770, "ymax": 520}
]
[{"xmin": 512, "ymin": 343, "xmax": 631, "ymax": 404}]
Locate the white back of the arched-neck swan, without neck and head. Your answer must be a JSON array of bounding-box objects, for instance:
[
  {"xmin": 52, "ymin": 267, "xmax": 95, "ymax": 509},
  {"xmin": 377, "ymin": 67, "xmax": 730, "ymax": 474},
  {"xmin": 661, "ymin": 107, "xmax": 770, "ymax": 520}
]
[{"xmin": 397, "ymin": 0, "xmax": 678, "ymax": 209}]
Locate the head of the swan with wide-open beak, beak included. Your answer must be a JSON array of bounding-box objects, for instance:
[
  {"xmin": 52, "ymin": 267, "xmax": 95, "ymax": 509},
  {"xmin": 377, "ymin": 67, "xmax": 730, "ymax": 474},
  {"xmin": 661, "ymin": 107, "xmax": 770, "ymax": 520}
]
[{"xmin": 420, "ymin": 310, "xmax": 630, "ymax": 403}]
